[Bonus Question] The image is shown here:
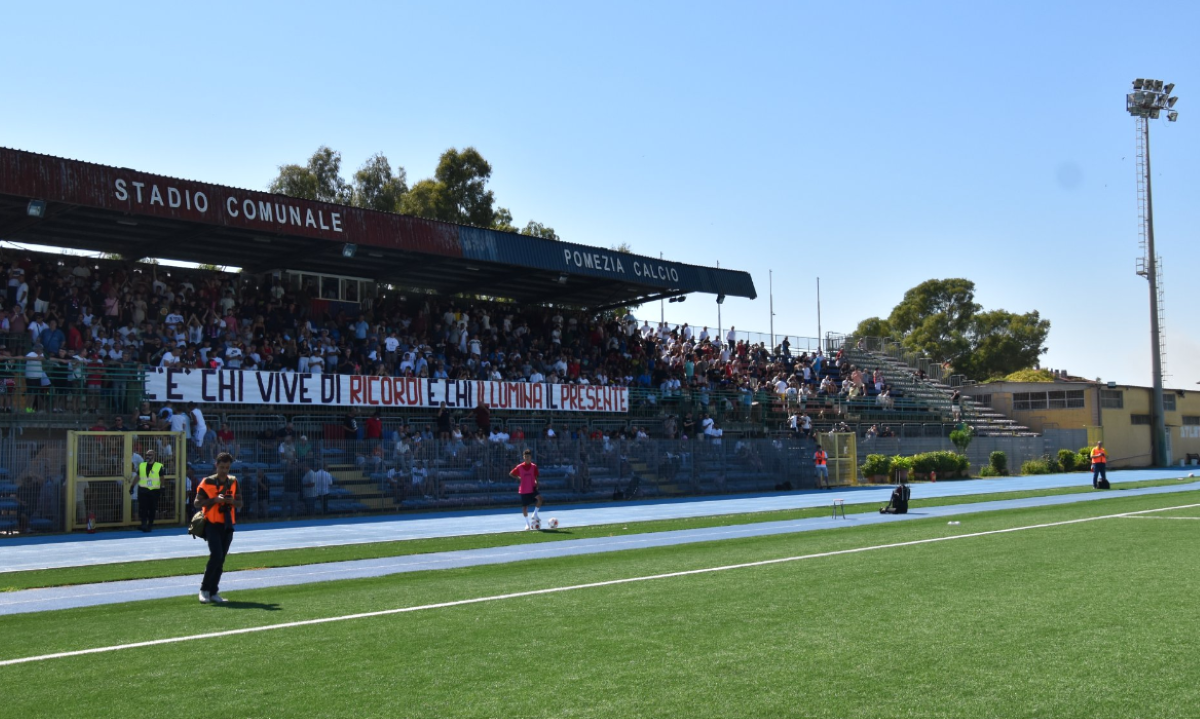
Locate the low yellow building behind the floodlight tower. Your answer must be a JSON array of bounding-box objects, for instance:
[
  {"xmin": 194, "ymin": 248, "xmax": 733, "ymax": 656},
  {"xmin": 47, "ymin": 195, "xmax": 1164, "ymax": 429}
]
[{"xmin": 961, "ymin": 378, "xmax": 1200, "ymax": 468}]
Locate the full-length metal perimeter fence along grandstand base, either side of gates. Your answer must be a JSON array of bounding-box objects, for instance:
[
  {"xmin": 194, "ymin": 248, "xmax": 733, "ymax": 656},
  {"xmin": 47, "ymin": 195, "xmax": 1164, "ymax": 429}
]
[{"xmin": 0, "ymin": 429, "xmax": 1080, "ymax": 533}]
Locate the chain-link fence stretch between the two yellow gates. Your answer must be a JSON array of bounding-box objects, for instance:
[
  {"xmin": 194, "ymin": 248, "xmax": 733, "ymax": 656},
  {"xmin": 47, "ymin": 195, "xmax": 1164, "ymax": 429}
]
[{"xmin": 191, "ymin": 435, "xmax": 835, "ymax": 519}]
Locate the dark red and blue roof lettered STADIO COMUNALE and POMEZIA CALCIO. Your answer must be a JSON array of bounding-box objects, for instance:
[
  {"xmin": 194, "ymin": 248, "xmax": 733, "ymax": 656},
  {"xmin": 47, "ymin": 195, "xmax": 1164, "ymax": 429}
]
[{"xmin": 0, "ymin": 148, "xmax": 757, "ymax": 306}]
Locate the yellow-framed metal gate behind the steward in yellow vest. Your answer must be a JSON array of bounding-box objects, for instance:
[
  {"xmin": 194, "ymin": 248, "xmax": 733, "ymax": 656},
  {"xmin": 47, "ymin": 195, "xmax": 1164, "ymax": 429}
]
[{"xmin": 66, "ymin": 432, "xmax": 187, "ymax": 532}]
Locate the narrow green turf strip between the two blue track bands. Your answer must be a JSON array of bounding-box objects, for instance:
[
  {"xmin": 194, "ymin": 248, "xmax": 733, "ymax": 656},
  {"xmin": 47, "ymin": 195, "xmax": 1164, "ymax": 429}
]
[{"xmin": 0, "ymin": 478, "xmax": 1178, "ymax": 592}]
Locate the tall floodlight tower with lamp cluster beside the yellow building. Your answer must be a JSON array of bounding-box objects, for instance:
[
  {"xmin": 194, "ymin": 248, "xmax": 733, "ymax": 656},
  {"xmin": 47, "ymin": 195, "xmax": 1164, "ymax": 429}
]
[{"xmin": 1126, "ymin": 78, "xmax": 1180, "ymax": 467}]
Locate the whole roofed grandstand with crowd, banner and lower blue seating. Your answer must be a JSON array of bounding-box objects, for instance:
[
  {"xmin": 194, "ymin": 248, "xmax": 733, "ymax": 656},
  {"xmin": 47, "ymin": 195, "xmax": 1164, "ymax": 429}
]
[{"xmin": 0, "ymin": 149, "xmax": 1024, "ymax": 533}]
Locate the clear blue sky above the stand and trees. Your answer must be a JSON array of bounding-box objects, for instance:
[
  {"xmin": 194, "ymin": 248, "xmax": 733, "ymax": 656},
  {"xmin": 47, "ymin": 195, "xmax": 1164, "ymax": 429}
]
[{"xmin": 0, "ymin": 2, "xmax": 1200, "ymax": 389}]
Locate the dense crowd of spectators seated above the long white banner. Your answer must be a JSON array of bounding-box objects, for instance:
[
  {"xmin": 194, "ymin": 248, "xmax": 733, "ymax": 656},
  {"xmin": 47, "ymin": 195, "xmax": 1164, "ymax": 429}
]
[{"xmin": 0, "ymin": 254, "xmax": 926, "ymax": 437}]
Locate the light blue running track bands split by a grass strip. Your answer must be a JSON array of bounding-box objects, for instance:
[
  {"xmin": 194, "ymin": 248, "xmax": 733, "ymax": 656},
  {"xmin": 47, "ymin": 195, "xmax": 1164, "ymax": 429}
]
[{"xmin": 0, "ymin": 472, "xmax": 1200, "ymax": 615}]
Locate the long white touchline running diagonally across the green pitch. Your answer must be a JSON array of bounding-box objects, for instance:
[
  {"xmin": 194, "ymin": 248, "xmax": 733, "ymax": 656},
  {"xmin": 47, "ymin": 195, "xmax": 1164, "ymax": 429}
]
[{"xmin": 0, "ymin": 504, "xmax": 1200, "ymax": 666}]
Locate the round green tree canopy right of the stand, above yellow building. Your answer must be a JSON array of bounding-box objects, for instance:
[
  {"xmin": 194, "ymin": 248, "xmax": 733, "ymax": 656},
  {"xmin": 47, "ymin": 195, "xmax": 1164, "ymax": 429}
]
[{"xmin": 854, "ymin": 278, "xmax": 1050, "ymax": 379}]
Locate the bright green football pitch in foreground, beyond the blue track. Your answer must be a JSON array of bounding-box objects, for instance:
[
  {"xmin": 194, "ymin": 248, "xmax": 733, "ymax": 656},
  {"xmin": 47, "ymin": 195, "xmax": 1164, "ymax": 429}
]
[{"xmin": 0, "ymin": 492, "xmax": 1200, "ymax": 718}]
